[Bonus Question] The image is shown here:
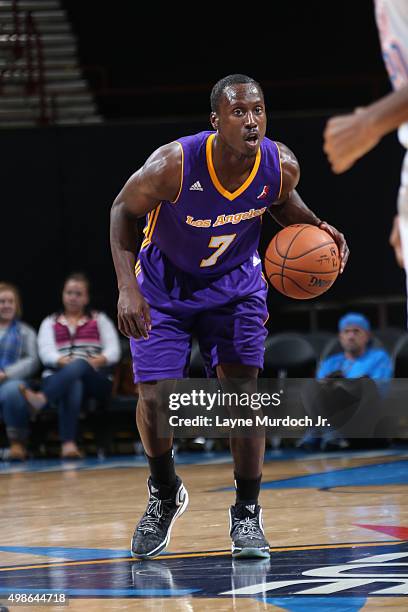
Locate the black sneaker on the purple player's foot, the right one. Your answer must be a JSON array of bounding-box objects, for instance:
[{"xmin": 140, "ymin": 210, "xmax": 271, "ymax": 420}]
[{"xmin": 229, "ymin": 504, "xmax": 270, "ymax": 559}]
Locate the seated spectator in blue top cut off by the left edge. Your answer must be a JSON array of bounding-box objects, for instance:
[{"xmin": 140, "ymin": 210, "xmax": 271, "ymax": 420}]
[{"xmin": 0, "ymin": 283, "xmax": 40, "ymax": 461}]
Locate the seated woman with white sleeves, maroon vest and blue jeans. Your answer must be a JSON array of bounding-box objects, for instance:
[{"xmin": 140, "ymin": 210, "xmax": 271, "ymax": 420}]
[{"xmin": 21, "ymin": 274, "xmax": 120, "ymax": 459}]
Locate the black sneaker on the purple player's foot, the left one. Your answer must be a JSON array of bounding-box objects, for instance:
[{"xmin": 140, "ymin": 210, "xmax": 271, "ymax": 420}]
[{"xmin": 130, "ymin": 477, "xmax": 188, "ymax": 559}]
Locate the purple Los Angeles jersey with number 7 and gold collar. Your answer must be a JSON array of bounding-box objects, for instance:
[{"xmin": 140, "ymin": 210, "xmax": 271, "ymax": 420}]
[{"xmin": 142, "ymin": 132, "xmax": 282, "ymax": 277}]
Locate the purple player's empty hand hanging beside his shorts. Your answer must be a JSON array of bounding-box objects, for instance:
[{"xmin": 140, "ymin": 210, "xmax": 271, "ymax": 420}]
[{"xmin": 118, "ymin": 287, "xmax": 152, "ymax": 339}]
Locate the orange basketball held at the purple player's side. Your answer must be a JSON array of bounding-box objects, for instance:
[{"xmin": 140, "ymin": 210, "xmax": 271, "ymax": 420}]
[{"xmin": 264, "ymin": 224, "xmax": 340, "ymax": 300}]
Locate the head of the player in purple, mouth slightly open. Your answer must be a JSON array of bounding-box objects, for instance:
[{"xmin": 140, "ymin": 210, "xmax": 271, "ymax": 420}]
[{"xmin": 210, "ymin": 74, "xmax": 266, "ymax": 157}]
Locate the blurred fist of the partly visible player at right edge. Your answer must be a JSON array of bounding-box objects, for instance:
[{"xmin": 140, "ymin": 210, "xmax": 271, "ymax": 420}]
[{"xmin": 323, "ymin": 108, "xmax": 380, "ymax": 174}]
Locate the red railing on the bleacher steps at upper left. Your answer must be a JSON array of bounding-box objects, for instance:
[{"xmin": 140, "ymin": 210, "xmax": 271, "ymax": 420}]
[{"xmin": 0, "ymin": 0, "xmax": 55, "ymax": 125}]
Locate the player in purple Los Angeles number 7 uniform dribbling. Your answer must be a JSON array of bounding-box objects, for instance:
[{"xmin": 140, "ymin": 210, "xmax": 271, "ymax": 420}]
[{"xmin": 111, "ymin": 74, "xmax": 348, "ymax": 558}]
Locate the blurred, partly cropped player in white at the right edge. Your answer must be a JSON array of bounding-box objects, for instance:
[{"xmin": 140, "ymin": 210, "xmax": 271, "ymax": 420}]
[{"xmin": 324, "ymin": 0, "xmax": 408, "ymax": 316}]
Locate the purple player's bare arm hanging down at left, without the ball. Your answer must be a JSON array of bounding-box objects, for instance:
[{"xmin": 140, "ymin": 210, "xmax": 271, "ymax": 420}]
[{"xmin": 110, "ymin": 142, "xmax": 182, "ymax": 338}]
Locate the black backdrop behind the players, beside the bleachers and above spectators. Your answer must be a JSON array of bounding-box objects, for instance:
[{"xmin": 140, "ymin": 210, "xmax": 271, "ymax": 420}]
[{"xmin": 1, "ymin": 0, "xmax": 404, "ymax": 331}]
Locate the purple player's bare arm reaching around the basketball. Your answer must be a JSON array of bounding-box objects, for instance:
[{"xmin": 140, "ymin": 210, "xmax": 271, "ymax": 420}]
[{"xmin": 269, "ymin": 143, "xmax": 349, "ymax": 274}]
